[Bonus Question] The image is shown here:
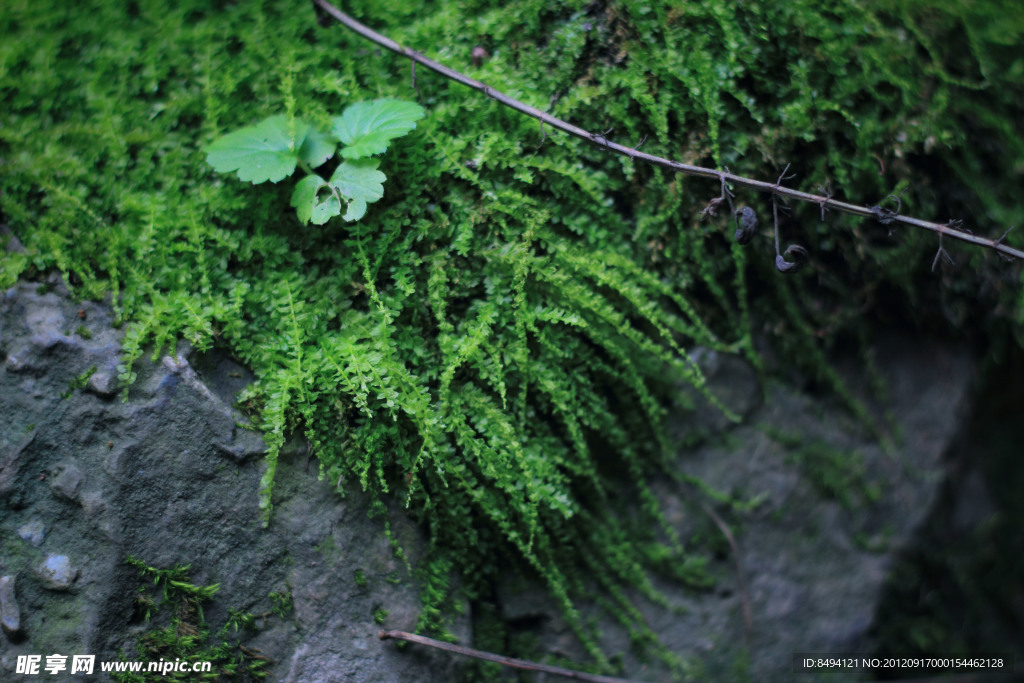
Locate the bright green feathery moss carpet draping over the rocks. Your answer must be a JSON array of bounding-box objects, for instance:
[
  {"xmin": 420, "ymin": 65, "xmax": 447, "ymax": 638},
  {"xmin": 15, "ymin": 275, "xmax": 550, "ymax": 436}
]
[{"xmin": 0, "ymin": 0, "xmax": 1024, "ymax": 671}]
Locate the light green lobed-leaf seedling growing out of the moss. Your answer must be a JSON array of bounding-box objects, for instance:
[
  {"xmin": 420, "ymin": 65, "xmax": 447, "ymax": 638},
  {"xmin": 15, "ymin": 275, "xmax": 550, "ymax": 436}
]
[{"xmin": 204, "ymin": 99, "xmax": 426, "ymax": 225}]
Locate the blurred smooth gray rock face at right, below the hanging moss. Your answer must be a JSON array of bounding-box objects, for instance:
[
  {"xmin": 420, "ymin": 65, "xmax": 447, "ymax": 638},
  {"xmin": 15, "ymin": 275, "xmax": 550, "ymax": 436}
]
[{"xmin": 499, "ymin": 341, "xmax": 974, "ymax": 681}]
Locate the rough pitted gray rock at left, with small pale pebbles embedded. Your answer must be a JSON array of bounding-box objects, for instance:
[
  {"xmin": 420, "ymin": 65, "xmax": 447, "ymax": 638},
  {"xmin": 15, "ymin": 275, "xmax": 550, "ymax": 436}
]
[{"xmin": 0, "ymin": 283, "xmax": 468, "ymax": 683}]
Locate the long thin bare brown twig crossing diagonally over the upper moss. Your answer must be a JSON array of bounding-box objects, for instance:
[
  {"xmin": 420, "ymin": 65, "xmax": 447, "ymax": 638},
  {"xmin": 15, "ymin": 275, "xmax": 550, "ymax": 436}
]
[{"xmin": 313, "ymin": 0, "xmax": 1024, "ymax": 260}]
